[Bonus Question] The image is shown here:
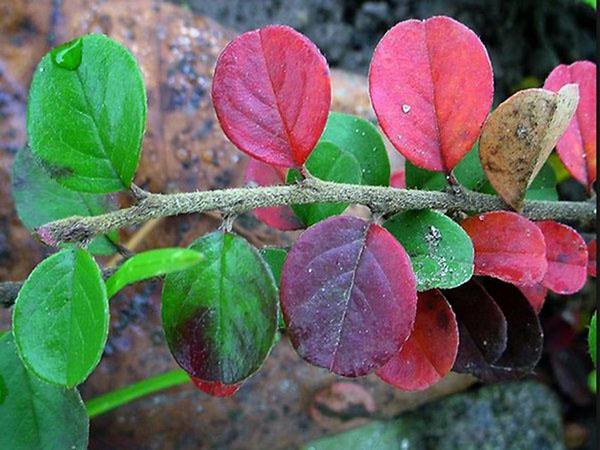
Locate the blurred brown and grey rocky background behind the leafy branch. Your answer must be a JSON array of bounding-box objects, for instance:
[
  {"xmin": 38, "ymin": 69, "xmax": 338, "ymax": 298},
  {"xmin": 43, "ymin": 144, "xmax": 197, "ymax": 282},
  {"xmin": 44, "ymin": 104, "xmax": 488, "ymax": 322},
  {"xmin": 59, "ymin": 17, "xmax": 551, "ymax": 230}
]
[{"xmin": 0, "ymin": 0, "xmax": 597, "ymax": 450}]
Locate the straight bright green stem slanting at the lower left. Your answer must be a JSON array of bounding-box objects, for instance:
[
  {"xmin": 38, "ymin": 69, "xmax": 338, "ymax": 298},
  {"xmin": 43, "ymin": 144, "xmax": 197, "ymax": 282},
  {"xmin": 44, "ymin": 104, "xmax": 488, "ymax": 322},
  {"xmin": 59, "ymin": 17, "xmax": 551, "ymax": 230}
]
[{"xmin": 85, "ymin": 369, "xmax": 190, "ymax": 419}]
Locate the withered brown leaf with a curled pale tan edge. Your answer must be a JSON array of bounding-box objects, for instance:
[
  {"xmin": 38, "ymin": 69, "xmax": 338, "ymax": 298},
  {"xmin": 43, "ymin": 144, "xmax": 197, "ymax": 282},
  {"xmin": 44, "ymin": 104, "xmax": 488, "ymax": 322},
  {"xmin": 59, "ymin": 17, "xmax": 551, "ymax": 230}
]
[{"xmin": 479, "ymin": 84, "xmax": 579, "ymax": 211}]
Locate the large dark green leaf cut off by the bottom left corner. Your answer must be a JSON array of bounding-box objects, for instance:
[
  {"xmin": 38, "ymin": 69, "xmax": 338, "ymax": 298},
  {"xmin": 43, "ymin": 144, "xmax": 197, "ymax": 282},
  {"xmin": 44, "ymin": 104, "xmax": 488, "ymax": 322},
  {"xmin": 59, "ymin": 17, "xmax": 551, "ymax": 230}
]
[{"xmin": 0, "ymin": 333, "xmax": 89, "ymax": 450}]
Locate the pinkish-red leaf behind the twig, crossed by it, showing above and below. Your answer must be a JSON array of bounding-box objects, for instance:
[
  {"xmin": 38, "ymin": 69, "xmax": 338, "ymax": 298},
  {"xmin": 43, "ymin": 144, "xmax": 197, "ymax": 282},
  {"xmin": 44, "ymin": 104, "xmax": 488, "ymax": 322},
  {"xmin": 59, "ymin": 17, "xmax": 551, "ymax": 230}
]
[{"xmin": 244, "ymin": 159, "xmax": 303, "ymax": 231}]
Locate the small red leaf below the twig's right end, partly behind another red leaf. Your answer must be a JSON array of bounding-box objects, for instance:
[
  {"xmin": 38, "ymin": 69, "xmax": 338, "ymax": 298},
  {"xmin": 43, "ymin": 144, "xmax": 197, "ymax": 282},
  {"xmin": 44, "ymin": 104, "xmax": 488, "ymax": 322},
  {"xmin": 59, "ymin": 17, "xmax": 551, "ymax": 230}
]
[{"xmin": 537, "ymin": 220, "xmax": 588, "ymax": 294}]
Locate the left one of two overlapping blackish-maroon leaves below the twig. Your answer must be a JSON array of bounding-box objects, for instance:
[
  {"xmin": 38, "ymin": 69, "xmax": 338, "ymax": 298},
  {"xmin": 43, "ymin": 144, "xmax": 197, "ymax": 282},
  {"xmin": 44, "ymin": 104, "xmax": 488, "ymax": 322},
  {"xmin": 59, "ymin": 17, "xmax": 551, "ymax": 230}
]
[{"xmin": 444, "ymin": 280, "xmax": 507, "ymax": 376}]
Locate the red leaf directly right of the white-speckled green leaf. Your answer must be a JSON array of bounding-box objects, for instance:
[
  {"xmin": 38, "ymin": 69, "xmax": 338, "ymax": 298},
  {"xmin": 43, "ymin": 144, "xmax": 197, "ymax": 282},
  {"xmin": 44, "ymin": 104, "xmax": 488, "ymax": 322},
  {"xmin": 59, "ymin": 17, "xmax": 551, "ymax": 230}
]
[{"xmin": 461, "ymin": 211, "xmax": 548, "ymax": 285}]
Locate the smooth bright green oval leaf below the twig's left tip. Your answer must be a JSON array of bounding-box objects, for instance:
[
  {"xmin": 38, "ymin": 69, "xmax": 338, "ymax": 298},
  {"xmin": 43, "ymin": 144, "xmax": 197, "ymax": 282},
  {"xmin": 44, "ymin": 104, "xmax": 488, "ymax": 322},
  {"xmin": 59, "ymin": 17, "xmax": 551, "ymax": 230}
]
[{"xmin": 13, "ymin": 249, "xmax": 109, "ymax": 387}]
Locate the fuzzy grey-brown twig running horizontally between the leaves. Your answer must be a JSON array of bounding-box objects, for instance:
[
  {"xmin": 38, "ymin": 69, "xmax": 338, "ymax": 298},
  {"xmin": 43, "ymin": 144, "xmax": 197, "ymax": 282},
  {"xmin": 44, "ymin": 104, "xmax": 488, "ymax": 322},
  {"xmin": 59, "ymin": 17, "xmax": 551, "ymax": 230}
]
[{"xmin": 36, "ymin": 178, "xmax": 596, "ymax": 246}]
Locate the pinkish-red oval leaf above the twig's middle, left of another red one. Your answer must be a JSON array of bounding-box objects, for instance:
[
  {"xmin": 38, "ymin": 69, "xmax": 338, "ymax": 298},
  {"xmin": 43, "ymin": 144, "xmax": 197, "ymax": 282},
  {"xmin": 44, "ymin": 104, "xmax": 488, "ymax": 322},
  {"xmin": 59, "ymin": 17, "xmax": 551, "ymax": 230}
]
[{"xmin": 212, "ymin": 25, "xmax": 331, "ymax": 167}]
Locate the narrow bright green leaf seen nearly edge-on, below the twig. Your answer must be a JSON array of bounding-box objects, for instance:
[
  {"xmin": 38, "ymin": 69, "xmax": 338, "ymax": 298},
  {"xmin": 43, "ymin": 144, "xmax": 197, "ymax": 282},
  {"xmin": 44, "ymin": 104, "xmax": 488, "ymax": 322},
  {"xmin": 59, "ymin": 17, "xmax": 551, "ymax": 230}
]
[{"xmin": 106, "ymin": 248, "xmax": 202, "ymax": 299}]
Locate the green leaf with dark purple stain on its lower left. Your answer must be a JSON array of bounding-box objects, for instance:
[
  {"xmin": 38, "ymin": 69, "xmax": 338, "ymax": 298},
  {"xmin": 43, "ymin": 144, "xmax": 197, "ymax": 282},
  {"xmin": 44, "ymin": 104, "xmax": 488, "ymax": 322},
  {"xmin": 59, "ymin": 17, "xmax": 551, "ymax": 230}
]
[{"xmin": 162, "ymin": 231, "xmax": 278, "ymax": 384}]
